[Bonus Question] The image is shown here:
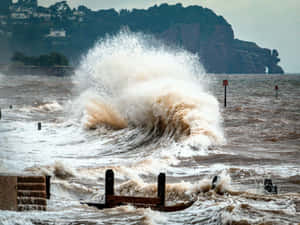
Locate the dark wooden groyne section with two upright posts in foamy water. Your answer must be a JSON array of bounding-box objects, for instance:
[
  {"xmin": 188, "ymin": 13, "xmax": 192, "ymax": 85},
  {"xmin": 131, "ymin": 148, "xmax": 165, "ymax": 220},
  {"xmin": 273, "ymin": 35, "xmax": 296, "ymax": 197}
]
[{"xmin": 82, "ymin": 170, "xmax": 194, "ymax": 212}]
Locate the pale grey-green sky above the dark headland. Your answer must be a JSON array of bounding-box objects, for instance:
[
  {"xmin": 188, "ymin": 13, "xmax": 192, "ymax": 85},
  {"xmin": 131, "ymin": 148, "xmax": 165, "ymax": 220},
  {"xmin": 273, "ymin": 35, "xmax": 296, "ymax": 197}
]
[{"xmin": 38, "ymin": 0, "xmax": 300, "ymax": 73}]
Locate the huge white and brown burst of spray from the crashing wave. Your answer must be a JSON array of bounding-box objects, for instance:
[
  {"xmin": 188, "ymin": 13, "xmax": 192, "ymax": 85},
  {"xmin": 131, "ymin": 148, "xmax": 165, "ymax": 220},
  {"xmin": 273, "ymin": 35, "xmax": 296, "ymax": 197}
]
[{"xmin": 74, "ymin": 31, "xmax": 224, "ymax": 145}]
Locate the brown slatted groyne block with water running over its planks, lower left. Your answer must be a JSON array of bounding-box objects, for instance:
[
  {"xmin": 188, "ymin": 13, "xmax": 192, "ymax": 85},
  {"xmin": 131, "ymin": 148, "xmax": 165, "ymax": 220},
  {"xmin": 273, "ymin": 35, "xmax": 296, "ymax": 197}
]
[{"xmin": 0, "ymin": 175, "xmax": 50, "ymax": 211}]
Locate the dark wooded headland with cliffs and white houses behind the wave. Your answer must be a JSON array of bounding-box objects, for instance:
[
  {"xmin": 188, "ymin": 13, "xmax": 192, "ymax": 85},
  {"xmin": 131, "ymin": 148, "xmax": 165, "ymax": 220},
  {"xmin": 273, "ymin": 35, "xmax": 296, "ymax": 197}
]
[{"xmin": 0, "ymin": 1, "xmax": 283, "ymax": 73}]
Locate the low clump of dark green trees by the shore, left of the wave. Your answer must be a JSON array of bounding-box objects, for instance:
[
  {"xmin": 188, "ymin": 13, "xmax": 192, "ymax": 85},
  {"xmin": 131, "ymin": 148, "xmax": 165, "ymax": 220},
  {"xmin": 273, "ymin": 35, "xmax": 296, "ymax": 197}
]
[{"xmin": 11, "ymin": 52, "xmax": 69, "ymax": 67}]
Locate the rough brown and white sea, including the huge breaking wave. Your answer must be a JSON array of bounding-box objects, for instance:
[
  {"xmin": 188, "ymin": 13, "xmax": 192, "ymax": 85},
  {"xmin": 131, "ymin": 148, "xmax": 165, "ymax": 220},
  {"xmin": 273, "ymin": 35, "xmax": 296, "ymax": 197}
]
[{"xmin": 0, "ymin": 33, "xmax": 300, "ymax": 225}]
